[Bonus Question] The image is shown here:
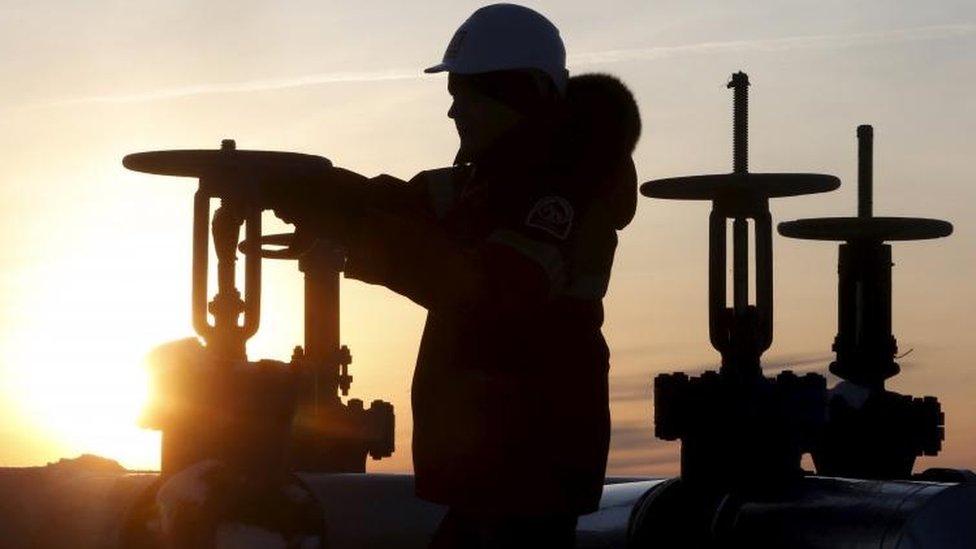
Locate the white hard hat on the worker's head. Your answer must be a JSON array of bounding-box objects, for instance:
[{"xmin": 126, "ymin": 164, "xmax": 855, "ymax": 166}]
[{"xmin": 424, "ymin": 4, "xmax": 569, "ymax": 93}]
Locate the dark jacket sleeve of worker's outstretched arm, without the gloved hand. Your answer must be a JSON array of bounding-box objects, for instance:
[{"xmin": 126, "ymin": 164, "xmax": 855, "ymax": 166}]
[{"xmin": 346, "ymin": 189, "xmax": 569, "ymax": 315}]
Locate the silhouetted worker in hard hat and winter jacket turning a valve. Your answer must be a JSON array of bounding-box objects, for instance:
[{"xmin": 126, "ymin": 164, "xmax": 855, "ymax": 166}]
[{"xmin": 269, "ymin": 4, "xmax": 640, "ymax": 548}]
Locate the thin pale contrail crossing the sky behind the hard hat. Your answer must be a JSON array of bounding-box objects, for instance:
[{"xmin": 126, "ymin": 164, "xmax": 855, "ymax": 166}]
[{"xmin": 49, "ymin": 23, "xmax": 976, "ymax": 106}]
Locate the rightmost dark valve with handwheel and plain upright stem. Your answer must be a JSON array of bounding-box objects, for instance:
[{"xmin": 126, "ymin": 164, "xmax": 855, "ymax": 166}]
[{"xmin": 779, "ymin": 125, "xmax": 952, "ymax": 479}]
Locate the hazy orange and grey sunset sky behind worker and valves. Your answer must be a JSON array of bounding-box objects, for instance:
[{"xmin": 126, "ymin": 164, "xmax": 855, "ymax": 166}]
[{"xmin": 0, "ymin": 0, "xmax": 976, "ymax": 474}]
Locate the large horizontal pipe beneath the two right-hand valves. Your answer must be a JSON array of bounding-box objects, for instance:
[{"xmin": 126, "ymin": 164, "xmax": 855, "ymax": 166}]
[{"xmin": 628, "ymin": 477, "xmax": 976, "ymax": 549}]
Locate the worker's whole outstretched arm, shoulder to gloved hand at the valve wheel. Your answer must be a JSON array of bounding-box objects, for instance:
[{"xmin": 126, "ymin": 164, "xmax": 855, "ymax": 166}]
[{"xmin": 266, "ymin": 169, "xmax": 592, "ymax": 315}]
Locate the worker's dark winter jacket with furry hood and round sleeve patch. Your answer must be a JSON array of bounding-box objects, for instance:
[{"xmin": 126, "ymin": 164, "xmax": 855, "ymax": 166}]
[{"xmin": 345, "ymin": 75, "xmax": 640, "ymax": 515}]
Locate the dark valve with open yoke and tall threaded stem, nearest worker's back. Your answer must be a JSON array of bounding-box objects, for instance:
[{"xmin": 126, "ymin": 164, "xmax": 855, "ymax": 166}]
[{"xmin": 641, "ymin": 72, "xmax": 840, "ymax": 490}]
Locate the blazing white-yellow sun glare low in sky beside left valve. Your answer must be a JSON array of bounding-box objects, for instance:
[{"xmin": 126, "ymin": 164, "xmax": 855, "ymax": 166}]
[{"xmin": 4, "ymin": 240, "xmax": 185, "ymax": 469}]
